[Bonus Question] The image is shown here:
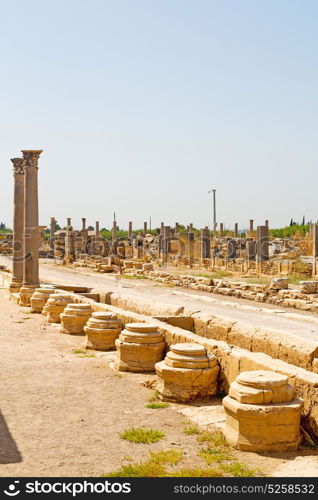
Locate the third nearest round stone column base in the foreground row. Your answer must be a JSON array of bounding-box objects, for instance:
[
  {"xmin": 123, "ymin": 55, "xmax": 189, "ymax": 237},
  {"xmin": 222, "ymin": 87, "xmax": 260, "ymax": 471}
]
[{"xmin": 115, "ymin": 323, "xmax": 166, "ymax": 372}]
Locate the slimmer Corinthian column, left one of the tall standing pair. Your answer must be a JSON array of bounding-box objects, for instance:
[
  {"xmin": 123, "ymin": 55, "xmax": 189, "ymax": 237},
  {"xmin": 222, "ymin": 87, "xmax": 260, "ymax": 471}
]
[{"xmin": 9, "ymin": 158, "xmax": 24, "ymax": 293}]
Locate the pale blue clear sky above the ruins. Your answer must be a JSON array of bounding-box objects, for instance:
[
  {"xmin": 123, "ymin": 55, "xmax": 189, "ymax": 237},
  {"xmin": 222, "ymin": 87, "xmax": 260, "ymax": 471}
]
[{"xmin": 0, "ymin": 0, "xmax": 318, "ymax": 228}]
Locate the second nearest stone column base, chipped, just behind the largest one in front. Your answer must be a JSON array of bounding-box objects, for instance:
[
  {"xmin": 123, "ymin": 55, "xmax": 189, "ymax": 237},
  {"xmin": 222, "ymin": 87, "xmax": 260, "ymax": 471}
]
[{"xmin": 155, "ymin": 343, "xmax": 219, "ymax": 402}]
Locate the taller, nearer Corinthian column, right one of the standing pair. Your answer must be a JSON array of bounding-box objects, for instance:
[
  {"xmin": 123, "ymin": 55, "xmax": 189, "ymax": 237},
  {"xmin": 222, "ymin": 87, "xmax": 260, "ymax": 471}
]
[{"xmin": 20, "ymin": 150, "xmax": 42, "ymax": 306}]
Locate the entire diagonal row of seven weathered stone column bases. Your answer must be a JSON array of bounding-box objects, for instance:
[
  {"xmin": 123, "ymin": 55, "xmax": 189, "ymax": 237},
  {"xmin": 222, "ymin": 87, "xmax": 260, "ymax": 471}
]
[{"xmin": 31, "ymin": 287, "xmax": 303, "ymax": 451}]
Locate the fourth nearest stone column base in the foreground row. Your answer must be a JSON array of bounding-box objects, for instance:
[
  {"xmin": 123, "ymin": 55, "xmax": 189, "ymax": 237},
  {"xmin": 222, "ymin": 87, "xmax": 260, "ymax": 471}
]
[{"xmin": 84, "ymin": 312, "xmax": 121, "ymax": 351}]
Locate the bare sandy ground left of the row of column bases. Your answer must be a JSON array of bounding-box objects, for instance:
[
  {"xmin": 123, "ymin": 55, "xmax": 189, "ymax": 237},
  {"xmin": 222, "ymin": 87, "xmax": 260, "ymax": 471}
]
[{"xmin": 0, "ymin": 289, "xmax": 318, "ymax": 476}]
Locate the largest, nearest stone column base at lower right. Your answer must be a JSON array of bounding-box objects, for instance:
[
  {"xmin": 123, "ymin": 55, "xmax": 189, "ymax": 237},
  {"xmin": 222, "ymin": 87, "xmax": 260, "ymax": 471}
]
[{"xmin": 223, "ymin": 370, "xmax": 303, "ymax": 452}]
